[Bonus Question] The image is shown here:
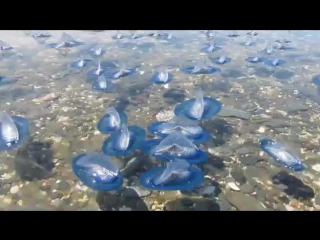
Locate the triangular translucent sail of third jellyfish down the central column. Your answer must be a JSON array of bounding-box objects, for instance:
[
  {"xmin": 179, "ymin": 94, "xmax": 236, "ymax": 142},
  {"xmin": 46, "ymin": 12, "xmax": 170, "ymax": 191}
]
[{"xmin": 153, "ymin": 132, "xmax": 198, "ymax": 157}]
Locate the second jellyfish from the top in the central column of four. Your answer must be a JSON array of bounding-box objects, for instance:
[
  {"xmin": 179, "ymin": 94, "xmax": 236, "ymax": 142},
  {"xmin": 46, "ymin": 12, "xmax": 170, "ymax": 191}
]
[{"xmin": 148, "ymin": 117, "xmax": 211, "ymax": 143}]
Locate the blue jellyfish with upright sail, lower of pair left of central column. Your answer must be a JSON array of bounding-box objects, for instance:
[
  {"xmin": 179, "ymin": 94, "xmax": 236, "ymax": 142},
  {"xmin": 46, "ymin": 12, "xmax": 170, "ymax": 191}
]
[{"xmin": 102, "ymin": 123, "xmax": 146, "ymax": 156}]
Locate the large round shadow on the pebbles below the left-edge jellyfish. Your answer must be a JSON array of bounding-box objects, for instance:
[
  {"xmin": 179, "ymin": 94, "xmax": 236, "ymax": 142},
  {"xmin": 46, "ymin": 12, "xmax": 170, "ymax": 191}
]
[{"xmin": 14, "ymin": 140, "xmax": 55, "ymax": 181}]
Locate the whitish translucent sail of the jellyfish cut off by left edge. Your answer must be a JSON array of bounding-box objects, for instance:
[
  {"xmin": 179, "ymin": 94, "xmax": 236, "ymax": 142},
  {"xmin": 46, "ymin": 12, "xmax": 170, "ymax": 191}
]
[{"xmin": 0, "ymin": 111, "xmax": 19, "ymax": 147}]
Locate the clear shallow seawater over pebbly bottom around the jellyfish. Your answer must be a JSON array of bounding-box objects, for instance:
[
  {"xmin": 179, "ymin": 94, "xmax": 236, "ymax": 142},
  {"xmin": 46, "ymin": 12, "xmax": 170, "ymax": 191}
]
[{"xmin": 0, "ymin": 31, "xmax": 320, "ymax": 211}]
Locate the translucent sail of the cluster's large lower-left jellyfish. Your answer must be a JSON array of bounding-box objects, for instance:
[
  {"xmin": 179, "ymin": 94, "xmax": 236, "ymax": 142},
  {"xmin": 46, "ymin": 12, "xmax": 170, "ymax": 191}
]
[{"xmin": 77, "ymin": 153, "xmax": 120, "ymax": 183}]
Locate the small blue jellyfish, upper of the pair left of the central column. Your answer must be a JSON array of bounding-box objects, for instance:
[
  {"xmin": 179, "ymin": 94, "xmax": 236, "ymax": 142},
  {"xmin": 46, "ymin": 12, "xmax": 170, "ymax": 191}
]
[{"xmin": 97, "ymin": 107, "xmax": 128, "ymax": 134}]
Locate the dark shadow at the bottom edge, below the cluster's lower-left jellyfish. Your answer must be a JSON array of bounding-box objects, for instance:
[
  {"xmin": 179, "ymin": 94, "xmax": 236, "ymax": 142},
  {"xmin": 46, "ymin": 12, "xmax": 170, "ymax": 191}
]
[{"xmin": 96, "ymin": 189, "xmax": 149, "ymax": 211}]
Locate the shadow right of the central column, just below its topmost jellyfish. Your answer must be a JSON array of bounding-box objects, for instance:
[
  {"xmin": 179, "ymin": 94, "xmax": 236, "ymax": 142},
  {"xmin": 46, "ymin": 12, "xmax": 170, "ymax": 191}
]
[{"xmin": 200, "ymin": 118, "xmax": 233, "ymax": 147}]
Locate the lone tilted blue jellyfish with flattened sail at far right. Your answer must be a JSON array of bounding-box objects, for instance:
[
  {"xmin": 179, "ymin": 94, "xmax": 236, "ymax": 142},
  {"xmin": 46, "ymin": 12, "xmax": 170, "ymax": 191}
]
[{"xmin": 260, "ymin": 138, "xmax": 305, "ymax": 172}]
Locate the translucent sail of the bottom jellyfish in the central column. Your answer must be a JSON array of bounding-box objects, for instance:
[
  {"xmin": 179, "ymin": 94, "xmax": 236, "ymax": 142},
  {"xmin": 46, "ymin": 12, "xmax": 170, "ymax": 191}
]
[{"xmin": 153, "ymin": 159, "xmax": 191, "ymax": 185}]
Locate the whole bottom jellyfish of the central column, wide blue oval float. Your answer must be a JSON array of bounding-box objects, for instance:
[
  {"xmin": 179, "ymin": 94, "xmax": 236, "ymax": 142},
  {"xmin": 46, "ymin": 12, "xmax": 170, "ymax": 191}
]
[{"xmin": 140, "ymin": 159, "xmax": 204, "ymax": 191}]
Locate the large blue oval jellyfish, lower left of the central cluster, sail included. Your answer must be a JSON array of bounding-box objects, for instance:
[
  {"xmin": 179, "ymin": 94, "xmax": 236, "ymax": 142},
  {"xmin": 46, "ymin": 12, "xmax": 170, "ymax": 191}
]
[{"xmin": 72, "ymin": 152, "xmax": 123, "ymax": 191}]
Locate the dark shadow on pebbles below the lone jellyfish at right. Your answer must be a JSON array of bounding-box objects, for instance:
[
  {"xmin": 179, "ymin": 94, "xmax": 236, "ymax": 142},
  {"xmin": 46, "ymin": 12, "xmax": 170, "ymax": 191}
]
[{"xmin": 272, "ymin": 171, "xmax": 315, "ymax": 200}]
